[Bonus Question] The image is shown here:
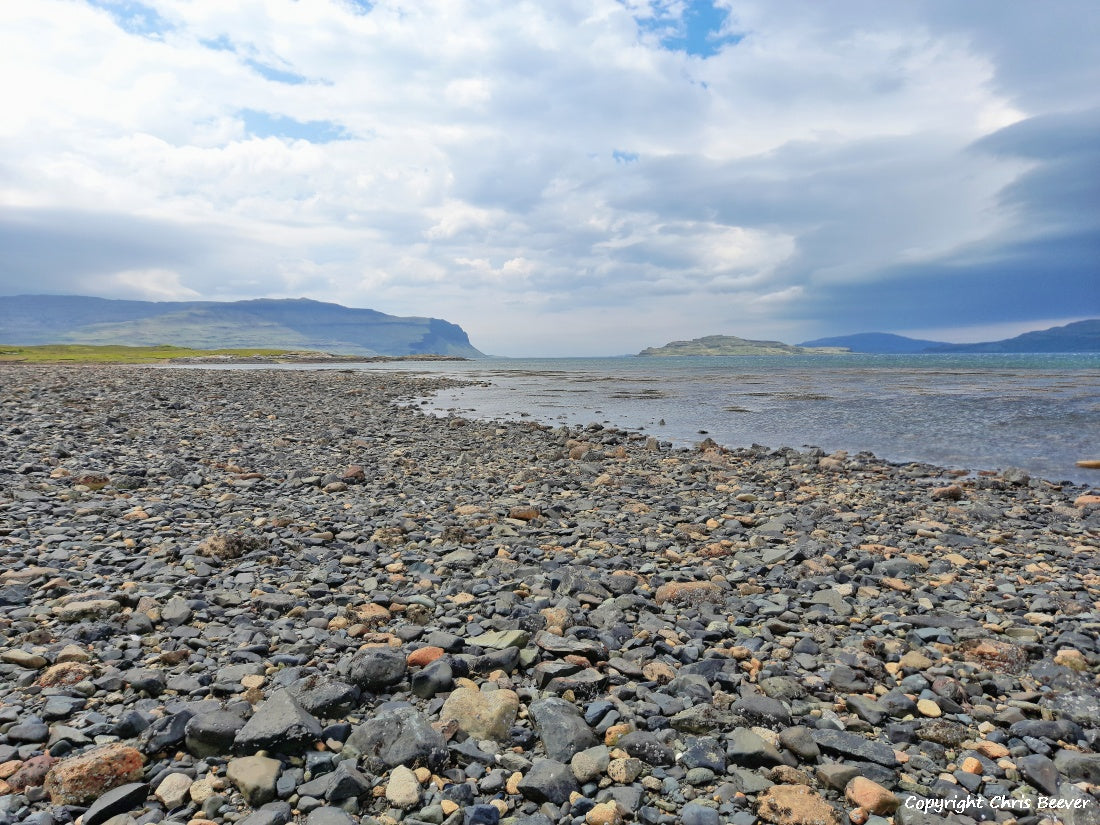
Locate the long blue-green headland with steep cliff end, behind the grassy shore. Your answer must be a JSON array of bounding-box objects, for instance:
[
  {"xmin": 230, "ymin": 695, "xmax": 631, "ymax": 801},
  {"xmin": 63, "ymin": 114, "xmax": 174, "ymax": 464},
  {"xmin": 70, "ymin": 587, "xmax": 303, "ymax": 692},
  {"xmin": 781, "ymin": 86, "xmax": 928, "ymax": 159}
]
[{"xmin": 0, "ymin": 295, "xmax": 482, "ymax": 358}]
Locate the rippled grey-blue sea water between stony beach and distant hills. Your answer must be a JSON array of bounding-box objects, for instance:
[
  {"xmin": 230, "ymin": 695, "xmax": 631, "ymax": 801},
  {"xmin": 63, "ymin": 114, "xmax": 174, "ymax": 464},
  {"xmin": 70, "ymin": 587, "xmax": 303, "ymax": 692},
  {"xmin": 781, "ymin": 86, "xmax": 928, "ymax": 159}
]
[{"xmin": 191, "ymin": 353, "xmax": 1100, "ymax": 487}]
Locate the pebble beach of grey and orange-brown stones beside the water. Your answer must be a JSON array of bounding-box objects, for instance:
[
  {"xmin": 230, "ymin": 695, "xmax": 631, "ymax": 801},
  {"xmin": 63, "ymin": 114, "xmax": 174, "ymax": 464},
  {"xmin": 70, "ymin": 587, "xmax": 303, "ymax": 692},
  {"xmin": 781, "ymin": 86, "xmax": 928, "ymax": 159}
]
[{"xmin": 0, "ymin": 365, "xmax": 1100, "ymax": 825}]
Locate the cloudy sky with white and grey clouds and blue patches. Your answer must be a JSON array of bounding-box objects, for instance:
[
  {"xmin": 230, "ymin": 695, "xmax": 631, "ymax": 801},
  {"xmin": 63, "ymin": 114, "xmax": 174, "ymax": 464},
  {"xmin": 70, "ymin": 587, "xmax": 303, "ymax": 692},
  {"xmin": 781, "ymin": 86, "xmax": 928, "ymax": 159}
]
[{"xmin": 0, "ymin": 0, "xmax": 1100, "ymax": 356}]
